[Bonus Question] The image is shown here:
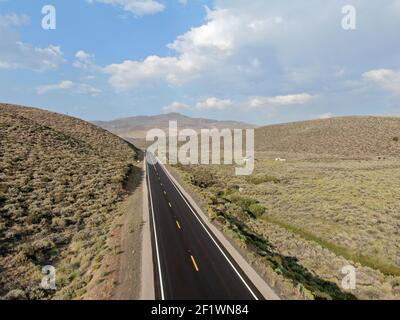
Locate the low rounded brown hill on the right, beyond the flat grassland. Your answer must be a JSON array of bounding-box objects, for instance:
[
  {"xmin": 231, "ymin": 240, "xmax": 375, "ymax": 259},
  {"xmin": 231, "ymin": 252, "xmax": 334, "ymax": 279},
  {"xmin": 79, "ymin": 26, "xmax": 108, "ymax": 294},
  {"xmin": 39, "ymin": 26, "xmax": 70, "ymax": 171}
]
[{"xmin": 256, "ymin": 117, "xmax": 400, "ymax": 158}]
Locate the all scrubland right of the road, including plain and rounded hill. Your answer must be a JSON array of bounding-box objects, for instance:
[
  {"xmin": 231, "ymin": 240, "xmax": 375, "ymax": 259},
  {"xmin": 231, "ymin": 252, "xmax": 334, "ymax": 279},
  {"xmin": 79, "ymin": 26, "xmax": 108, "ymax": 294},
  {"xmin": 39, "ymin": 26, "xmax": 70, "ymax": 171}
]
[{"xmin": 174, "ymin": 117, "xmax": 400, "ymax": 299}]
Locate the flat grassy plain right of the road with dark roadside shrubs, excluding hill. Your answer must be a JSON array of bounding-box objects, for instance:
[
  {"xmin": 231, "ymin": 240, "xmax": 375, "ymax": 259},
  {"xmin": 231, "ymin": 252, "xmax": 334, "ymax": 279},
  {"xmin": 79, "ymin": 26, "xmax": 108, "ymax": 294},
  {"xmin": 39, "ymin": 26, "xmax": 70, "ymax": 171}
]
[{"xmin": 176, "ymin": 160, "xmax": 400, "ymax": 299}]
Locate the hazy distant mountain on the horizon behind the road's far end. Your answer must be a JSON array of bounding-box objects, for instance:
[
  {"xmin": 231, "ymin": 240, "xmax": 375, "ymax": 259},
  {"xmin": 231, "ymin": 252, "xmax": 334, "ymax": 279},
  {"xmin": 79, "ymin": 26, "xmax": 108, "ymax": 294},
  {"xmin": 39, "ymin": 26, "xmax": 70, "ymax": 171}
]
[{"xmin": 94, "ymin": 113, "xmax": 256, "ymax": 139}]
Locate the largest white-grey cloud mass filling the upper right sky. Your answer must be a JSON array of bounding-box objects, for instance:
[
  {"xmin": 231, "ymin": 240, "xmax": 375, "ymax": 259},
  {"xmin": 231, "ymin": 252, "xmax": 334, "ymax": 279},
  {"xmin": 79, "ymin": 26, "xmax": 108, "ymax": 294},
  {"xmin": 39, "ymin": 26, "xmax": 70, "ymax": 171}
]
[{"xmin": 104, "ymin": 0, "xmax": 400, "ymax": 119}]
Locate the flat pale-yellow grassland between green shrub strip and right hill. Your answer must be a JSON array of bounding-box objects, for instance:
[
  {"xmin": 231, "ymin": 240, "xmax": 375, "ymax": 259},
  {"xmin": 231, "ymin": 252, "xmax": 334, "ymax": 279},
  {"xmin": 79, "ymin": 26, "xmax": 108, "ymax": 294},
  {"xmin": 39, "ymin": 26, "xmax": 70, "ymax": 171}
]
[{"xmin": 246, "ymin": 160, "xmax": 400, "ymax": 276}]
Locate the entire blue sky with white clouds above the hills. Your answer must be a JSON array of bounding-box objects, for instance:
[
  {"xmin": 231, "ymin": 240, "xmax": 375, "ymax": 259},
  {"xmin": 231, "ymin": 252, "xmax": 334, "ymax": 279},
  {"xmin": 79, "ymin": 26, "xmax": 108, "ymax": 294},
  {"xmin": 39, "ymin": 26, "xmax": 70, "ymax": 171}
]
[{"xmin": 0, "ymin": 0, "xmax": 400, "ymax": 125}]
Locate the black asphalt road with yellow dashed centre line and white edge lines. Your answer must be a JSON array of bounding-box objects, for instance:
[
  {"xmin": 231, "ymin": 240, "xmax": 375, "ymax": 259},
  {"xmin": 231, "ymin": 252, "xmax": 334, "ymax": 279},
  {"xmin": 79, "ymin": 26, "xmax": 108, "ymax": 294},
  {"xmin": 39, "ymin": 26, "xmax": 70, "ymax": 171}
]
[{"xmin": 147, "ymin": 152, "xmax": 263, "ymax": 300}]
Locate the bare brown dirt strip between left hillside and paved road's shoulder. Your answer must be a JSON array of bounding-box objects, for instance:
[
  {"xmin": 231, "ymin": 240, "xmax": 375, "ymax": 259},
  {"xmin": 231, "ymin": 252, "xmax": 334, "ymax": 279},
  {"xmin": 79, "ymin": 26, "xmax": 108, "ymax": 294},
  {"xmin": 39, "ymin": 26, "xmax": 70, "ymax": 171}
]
[{"xmin": 84, "ymin": 168, "xmax": 144, "ymax": 300}]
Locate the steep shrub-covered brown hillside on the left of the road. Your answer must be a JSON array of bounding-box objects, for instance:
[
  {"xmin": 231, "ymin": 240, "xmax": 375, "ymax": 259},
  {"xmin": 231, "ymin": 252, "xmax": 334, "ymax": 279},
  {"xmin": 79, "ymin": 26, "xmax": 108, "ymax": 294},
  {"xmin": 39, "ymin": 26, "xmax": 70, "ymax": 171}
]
[{"xmin": 0, "ymin": 104, "xmax": 139, "ymax": 299}]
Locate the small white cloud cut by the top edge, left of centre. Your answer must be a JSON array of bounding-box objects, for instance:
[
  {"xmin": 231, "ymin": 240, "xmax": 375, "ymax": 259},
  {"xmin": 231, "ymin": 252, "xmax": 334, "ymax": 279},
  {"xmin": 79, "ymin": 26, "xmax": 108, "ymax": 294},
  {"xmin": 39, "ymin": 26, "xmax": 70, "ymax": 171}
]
[{"xmin": 86, "ymin": 0, "xmax": 165, "ymax": 16}]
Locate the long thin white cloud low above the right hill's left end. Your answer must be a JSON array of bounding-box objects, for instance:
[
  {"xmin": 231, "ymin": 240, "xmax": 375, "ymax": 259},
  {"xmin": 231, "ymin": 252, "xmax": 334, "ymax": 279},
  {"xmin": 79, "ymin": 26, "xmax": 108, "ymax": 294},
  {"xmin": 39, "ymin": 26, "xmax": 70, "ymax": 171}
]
[{"xmin": 248, "ymin": 93, "xmax": 315, "ymax": 108}]
